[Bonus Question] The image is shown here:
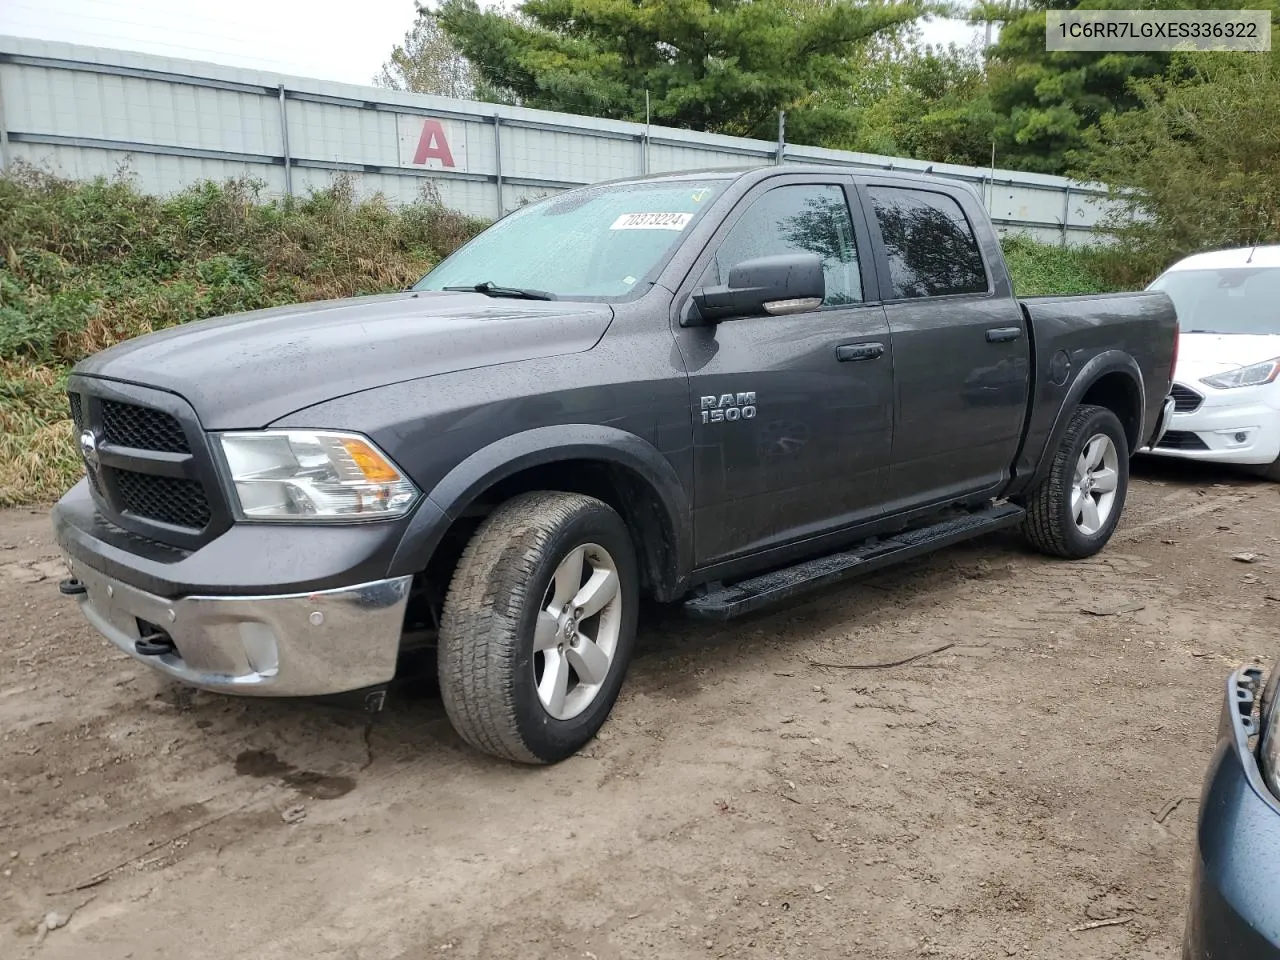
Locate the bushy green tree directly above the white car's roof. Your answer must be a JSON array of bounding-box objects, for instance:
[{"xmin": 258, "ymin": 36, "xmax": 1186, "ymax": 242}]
[{"xmin": 1076, "ymin": 54, "xmax": 1280, "ymax": 275}]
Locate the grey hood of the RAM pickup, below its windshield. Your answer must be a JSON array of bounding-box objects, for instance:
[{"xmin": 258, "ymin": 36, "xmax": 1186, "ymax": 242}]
[{"xmin": 76, "ymin": 292, "xmax": 613, "ymax": 430}]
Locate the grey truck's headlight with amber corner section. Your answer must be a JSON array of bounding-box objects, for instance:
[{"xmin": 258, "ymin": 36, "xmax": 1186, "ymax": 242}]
[{"xmin": 218, "ymin": 430, "xmax": 417, "ymax": 521}]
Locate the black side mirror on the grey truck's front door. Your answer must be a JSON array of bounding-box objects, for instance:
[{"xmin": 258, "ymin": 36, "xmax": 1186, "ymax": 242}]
[{"xmin": 682, "ymin": 253, "xmax": 827, "ymax": 326}]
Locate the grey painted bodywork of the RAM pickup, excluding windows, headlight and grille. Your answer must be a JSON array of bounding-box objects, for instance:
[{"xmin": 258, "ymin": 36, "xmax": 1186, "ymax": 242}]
[{"xmin": 54, "ymin": 166, "xmax": 1175, "ymax": 701}]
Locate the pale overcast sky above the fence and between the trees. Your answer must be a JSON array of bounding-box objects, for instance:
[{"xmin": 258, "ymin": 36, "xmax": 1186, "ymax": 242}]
[{"xmin": 0, "ymin": 0, "xmax": 975, "ymax": 83}]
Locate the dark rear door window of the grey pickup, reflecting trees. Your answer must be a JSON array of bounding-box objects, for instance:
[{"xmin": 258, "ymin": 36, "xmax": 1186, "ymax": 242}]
[{"xmin": 867, "ymin": 187, "xmax": 987, "ymax": 300}]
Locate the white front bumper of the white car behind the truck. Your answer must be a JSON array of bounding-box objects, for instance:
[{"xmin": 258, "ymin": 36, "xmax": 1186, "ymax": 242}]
[{"xmin": 1146, "ymin": 388, "xmax": 1280, "ymax": 465}]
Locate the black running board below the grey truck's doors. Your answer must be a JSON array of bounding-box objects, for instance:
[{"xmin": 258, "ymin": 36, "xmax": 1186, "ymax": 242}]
[{"xmin": 685, "ymin": 503, "xmax": 1027, "ymax": 620}]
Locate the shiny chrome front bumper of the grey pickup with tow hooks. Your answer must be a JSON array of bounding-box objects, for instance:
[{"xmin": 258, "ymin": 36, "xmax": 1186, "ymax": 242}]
[{"xmin": 69, "ymin": 561, "xmax": 412, "ymax": 696}]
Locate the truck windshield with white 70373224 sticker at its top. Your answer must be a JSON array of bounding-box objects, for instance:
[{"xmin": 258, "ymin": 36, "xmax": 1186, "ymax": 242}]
[{"xmin": 413, "ymin": 180, "xmax": 727, "ymax": 300}]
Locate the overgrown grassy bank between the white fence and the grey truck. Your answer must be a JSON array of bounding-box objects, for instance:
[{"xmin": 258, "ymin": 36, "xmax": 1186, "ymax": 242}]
[{"xmin": 0, "ymin": 169, "xmax": 1136, "ymax": 504}]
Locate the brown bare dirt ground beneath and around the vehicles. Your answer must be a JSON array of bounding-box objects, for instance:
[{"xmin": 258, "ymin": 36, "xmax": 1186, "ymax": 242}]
[{"xmin": 0, "ymin": 465, "xmax": 1280, "ymax": 960}]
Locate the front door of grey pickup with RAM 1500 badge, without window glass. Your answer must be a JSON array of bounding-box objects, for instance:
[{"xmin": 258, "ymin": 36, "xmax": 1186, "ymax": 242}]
[{"xmin": 671, "ymin": 170, "xmax": 893, "ymax": 566}]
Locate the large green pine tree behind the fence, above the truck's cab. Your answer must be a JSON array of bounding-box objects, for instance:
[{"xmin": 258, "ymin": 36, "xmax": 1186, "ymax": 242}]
[{"xmin": 439, "ymin": 0, "xmax": 925, "ymax": 143}]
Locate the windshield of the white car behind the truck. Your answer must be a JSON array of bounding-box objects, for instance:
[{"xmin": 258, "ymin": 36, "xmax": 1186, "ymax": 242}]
[{"xmin": 1151, "ymin": 266, "xmax": 1280, "ymax": 333}]
